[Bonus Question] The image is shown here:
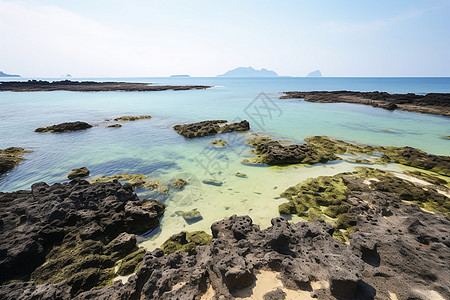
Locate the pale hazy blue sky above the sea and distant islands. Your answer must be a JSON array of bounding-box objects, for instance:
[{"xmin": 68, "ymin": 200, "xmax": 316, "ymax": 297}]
[{"xmin": 0, "ymin": 0, "xmax": 450, "ymax": 77}]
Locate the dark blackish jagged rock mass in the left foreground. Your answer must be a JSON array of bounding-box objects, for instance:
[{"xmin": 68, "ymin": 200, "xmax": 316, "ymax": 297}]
[{"xmin": 0, "ymin": 180, "xmax": 164, "ymax": 298}]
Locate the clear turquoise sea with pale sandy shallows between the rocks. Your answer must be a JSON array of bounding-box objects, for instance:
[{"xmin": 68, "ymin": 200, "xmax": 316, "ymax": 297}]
[{"xmin": 0, "ymin": 78, "xmax": 450, "ymax": 249}]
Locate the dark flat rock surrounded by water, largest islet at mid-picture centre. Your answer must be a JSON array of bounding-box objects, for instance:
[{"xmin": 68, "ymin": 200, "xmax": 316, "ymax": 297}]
[{"xmin": 173, "ymin": 120, "xmax": 250, "ymax": 138}]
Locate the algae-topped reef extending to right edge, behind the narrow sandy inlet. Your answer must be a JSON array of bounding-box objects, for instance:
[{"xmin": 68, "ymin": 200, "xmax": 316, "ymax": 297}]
[{"xmin": 242, "ymin": 136, "xmax": 450, "ymax": 176}]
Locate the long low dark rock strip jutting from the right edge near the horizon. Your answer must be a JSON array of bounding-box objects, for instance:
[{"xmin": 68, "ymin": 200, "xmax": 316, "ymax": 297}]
[{"xmin": 281, "ymin": 91, "xmax": 450, "ymax": 117}]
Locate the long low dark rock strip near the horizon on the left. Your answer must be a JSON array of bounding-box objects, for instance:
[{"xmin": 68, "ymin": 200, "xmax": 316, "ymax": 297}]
[{"xmin": 0, "ymin": 80, "xmax": 210, "ymax": 92}]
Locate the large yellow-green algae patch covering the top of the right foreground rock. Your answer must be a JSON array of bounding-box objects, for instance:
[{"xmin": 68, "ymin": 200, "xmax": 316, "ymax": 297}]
[{"xmin": 279, "ymin": 167, "xmax": 450, "ymax": 241}]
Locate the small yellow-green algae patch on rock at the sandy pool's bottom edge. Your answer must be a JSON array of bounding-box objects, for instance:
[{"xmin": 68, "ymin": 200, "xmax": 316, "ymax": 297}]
[{"xmin": 161, "ymin": 231, "xmax": 212, "ymax": 255}]
